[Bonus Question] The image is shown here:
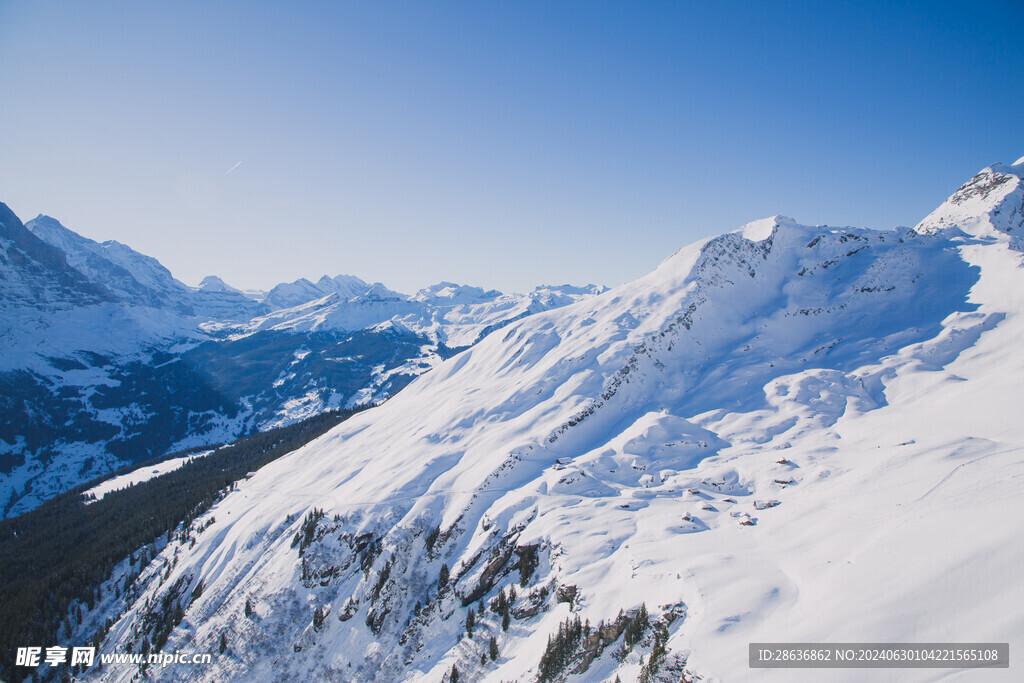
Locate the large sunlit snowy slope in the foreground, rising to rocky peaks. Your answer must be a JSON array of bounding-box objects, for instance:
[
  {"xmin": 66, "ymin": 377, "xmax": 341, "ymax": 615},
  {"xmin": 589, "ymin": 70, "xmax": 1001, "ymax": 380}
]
[{"xmin": 81, "ymin": 165, "xmax": 1024, "ymax": 681}]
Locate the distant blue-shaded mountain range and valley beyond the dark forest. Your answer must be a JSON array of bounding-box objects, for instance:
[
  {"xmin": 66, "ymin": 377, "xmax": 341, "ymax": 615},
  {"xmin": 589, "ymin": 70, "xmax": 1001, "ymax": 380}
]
[{"xmin": 0, "ymin": 210, "xmax": 597, "ymax": 516}]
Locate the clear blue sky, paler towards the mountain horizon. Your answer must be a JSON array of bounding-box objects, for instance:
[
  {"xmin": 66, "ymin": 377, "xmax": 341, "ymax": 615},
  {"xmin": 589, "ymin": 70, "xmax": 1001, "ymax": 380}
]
[{"xmin": 0, "ymin": 0, "xmax": 1024, "ymax": 292}]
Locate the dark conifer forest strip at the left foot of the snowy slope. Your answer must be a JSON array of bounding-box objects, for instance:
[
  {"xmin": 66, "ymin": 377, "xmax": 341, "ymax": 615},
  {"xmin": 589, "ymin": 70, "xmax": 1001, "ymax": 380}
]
[{"xmin": 0, "ymin": 409, "xmax": 362, "ymax": 680}]
